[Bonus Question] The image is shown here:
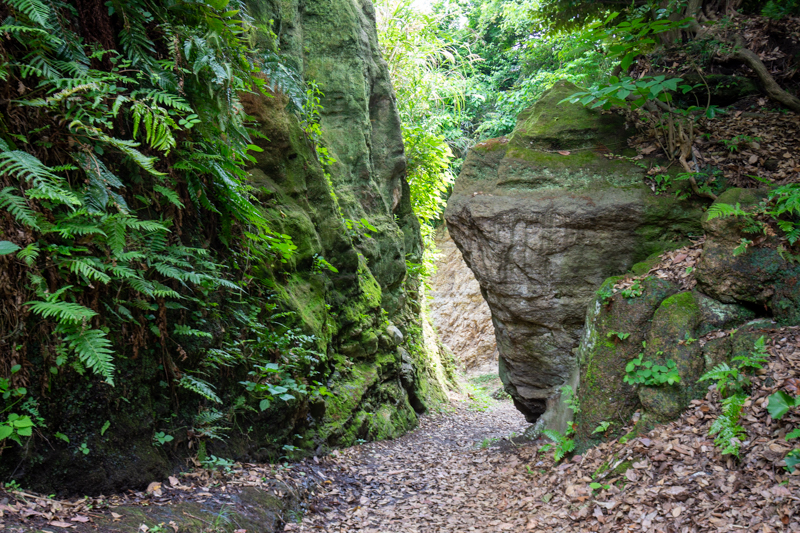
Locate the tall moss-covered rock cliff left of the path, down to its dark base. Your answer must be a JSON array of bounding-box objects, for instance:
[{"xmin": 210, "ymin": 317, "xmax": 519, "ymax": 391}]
[{"xmin": 0, "ymin": 0, "xmax": 452, "ymax": 494}]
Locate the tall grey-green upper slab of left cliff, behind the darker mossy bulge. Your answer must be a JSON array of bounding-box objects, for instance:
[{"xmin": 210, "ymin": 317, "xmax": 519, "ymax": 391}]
[{"xmin": 249, "ymin": 0, "xmax": 422, "ymax": 314}]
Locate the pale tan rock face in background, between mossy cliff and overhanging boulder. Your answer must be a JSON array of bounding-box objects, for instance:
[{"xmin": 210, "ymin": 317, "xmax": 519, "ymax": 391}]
[{"xmin": 430, "ymin": 230, "xmax": 497, "ymax": 373}]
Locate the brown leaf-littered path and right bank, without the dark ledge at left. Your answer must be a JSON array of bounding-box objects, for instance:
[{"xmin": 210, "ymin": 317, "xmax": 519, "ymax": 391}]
[{"xmin": 285, "ymin": 328, "xmax": 800, "ymax": 533}]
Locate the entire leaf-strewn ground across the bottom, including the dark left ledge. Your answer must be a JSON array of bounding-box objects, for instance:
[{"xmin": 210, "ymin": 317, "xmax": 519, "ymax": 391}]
[{"xmin": 0, "ymin": 342, "xmax": 800, "ymax": 533}]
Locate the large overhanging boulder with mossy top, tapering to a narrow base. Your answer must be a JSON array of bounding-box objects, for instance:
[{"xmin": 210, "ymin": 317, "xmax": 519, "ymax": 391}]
[{"xmin": 446, "ymin": 82, "xmax": 700, "ymax": 421}]
